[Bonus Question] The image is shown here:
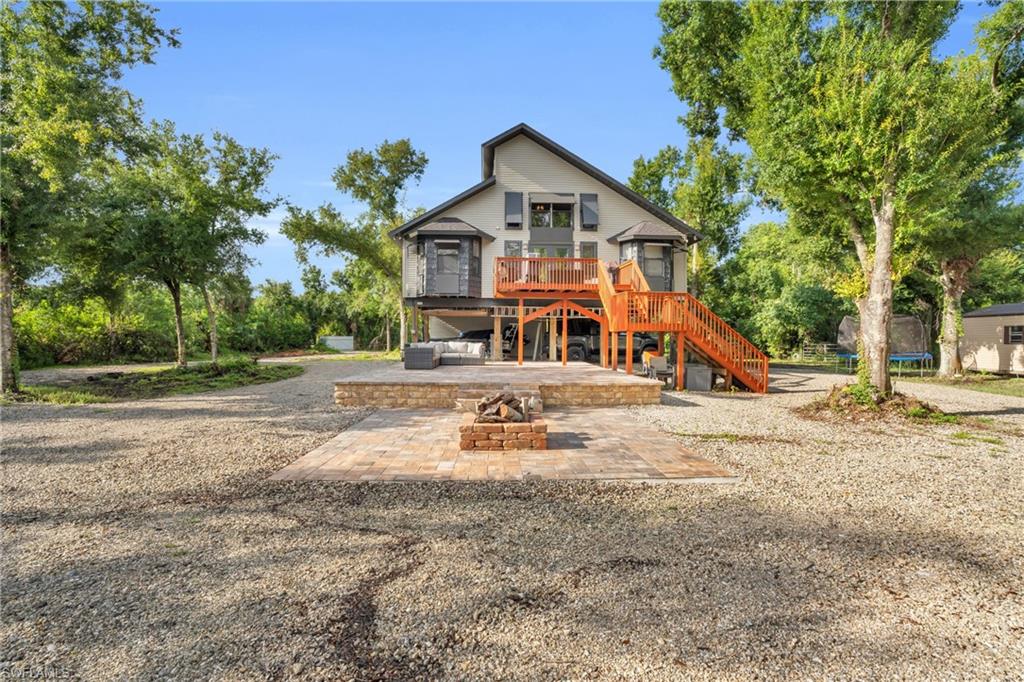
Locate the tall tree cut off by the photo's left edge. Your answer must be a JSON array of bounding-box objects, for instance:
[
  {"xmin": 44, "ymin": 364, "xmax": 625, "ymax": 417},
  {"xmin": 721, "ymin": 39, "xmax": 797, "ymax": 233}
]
[{"xmin": 0, "ymin": 0, "xmax": 178, "ymax": 391}]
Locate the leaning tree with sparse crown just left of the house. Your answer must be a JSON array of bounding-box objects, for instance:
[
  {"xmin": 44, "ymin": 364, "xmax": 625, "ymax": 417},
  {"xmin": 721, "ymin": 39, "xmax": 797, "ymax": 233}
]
[{"xmin": 282, "ymin": 139, "xmax": 427, "ymax": 344}]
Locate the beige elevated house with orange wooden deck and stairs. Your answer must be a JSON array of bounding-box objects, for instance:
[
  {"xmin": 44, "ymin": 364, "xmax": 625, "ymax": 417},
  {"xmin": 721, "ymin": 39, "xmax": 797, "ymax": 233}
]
[{"xmin": 391, "ymin": 124, "xmax": 767, "ymax": 390}]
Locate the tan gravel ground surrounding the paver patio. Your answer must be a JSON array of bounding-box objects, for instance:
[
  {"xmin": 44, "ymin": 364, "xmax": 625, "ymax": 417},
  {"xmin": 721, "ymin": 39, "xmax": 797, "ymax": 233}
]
[{"xmin": 0, "ymin": 361, "xmax": 1024, "ymax": 680}]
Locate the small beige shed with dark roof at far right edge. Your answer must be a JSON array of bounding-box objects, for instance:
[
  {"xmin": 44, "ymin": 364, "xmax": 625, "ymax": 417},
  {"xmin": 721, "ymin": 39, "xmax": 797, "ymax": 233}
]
[{"xmin": 959, "ymin": 302, "xmax": 1024, "ymax": 374}]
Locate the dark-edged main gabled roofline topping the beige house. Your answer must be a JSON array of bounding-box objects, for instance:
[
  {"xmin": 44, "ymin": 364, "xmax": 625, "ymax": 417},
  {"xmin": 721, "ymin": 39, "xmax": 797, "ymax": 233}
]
[{"xmin": 389, "ymin": 123, "xmax": 703, "ymax": 244}]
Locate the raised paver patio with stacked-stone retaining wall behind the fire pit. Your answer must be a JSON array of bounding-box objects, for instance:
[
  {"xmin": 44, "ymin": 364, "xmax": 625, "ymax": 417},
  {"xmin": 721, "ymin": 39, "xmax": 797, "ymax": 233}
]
[{"xmin": 334, "ymin": 363, "xmax": 662, "ymax": 408}]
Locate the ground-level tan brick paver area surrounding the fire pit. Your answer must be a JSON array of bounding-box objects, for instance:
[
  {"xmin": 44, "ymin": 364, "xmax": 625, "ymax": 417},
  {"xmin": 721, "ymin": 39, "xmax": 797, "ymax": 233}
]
[{"xmin": 271, "ymin": 408, "xmax": 731, "ymax": 481}]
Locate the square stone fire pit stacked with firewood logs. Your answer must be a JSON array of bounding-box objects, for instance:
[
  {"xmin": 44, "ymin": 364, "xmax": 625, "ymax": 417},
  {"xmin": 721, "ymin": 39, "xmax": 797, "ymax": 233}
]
[{"xmin": 459, "ymin": 390, "xmax": 548, "ymax": 450}]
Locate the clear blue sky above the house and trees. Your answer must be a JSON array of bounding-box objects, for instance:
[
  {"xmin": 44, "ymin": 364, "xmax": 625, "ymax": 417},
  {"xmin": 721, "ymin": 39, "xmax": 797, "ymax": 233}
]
[{"xmin": 125, "ymin": 2, "xmax": 987, "ymax": 289}]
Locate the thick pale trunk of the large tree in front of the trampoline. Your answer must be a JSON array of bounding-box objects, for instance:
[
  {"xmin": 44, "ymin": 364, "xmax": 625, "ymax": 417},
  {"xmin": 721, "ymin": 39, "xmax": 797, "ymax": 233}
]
[{"xmin": 860, "ymin": 191, "xmax": 896, "ymax": 396}]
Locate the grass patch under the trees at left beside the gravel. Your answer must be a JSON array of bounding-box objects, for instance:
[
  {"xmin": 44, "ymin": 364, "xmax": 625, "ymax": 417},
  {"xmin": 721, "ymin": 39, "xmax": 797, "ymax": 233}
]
[{"xmin": 5, "ymin": 359, "xmax": 303, "ymax": 404}]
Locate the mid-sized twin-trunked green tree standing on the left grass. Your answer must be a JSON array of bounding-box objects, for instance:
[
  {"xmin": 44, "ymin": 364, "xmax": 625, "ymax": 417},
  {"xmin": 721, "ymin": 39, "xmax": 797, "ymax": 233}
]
[{"xmin": 105, "ymin": 123, "xmax": 275, "ymax": 367}]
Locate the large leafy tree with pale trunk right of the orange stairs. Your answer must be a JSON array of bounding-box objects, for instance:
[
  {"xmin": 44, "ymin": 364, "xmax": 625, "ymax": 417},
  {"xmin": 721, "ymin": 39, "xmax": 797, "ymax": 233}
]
[{"xmin": 655, "ymin": 1, "xmax": 1008, "ymax": 396}]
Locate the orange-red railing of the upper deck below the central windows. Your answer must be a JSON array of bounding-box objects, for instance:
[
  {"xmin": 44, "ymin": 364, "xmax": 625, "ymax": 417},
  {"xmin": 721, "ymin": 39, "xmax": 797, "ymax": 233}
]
[{"xmin": 495, "ymin": 257, "xmax": 598, "ymax": 294}]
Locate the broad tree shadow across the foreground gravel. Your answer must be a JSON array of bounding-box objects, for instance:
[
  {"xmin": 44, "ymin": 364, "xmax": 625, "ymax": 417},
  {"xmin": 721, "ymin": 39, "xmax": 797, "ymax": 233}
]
[{"xmin": 0, "ymin": 476, "xmax": 1016, "ymax": 679}]
